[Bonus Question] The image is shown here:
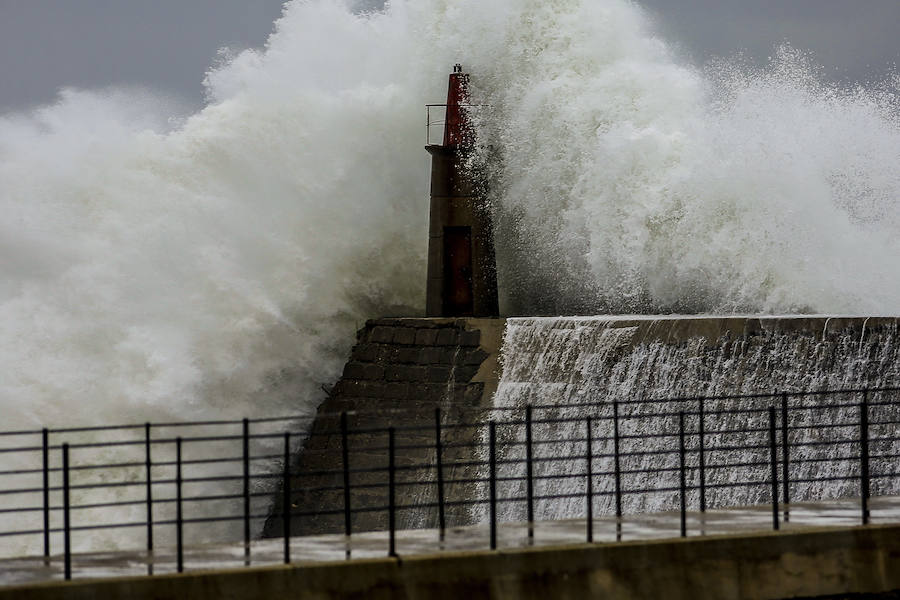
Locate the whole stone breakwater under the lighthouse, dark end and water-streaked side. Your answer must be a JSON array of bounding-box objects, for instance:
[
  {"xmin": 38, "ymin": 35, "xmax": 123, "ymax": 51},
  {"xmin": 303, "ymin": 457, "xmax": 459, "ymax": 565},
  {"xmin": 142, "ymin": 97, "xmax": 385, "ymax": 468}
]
[{"xmin": 267, "ymin": 316, "xmax": 900, "ymax": 533}]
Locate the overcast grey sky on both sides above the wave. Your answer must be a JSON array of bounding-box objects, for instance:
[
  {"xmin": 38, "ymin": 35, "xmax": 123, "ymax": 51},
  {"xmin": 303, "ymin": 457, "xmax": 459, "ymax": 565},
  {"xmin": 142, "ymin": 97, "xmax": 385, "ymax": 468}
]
[{"xmin": 0, "ymin": 0, "xmax": 900, "ymax": 110}]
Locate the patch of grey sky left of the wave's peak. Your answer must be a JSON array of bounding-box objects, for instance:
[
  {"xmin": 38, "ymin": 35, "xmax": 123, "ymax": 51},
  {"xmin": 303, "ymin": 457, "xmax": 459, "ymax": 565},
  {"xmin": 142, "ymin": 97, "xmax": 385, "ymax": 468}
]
[{"xmin": 0, "ymin": 0, "xmax": 284, "ymax": 110}]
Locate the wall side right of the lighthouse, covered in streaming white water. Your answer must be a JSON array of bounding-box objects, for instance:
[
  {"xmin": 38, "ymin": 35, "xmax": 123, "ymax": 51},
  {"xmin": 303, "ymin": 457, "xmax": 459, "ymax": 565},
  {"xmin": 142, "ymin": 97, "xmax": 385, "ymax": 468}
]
[{"xmin": 476, "ymin": 317, "xmax": 900, "ymax": 520}]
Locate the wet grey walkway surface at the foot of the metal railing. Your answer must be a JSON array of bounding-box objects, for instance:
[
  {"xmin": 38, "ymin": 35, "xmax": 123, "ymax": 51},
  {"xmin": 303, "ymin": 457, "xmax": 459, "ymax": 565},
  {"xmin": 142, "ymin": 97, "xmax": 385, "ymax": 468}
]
[{"xmin": 0, "ymin": 496, "xmax": 900, "ymax": 585}]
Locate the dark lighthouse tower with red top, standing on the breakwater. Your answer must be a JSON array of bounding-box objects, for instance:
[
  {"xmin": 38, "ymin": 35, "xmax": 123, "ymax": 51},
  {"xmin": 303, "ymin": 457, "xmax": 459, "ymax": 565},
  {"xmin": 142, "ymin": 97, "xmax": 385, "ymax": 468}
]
[{"xmin": 425, "ymin": 65, "xmax": 499, "ymax": 317}]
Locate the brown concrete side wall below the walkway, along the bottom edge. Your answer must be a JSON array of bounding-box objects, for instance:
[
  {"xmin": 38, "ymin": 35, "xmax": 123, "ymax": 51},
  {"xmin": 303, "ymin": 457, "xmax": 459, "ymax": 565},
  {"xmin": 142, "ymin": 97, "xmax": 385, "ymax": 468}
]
[{"xmin": 7, "ymin": 526, "xmax": 900, "ymax": 600}]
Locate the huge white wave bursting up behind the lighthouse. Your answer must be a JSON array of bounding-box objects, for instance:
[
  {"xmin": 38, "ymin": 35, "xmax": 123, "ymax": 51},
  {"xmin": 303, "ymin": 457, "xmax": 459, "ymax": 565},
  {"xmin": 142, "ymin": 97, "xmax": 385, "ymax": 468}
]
[{"xmin": 0, "ymin": 0, "xmax": 900, "ymax": 551}]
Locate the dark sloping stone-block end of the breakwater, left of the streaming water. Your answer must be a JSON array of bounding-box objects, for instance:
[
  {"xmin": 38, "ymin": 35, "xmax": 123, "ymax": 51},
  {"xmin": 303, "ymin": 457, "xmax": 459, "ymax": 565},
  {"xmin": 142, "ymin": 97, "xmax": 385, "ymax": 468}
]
[{"xmin": 264, "ymin": 319, "xmax": 504, "ymax": 535}]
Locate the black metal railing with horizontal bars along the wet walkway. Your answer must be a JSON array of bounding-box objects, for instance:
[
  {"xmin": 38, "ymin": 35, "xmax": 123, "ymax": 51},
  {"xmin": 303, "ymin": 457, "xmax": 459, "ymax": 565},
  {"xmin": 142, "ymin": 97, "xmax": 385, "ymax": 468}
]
[{"xmin": 0, "ymin": 388, "xmax": 900, "ymax": 579}]
